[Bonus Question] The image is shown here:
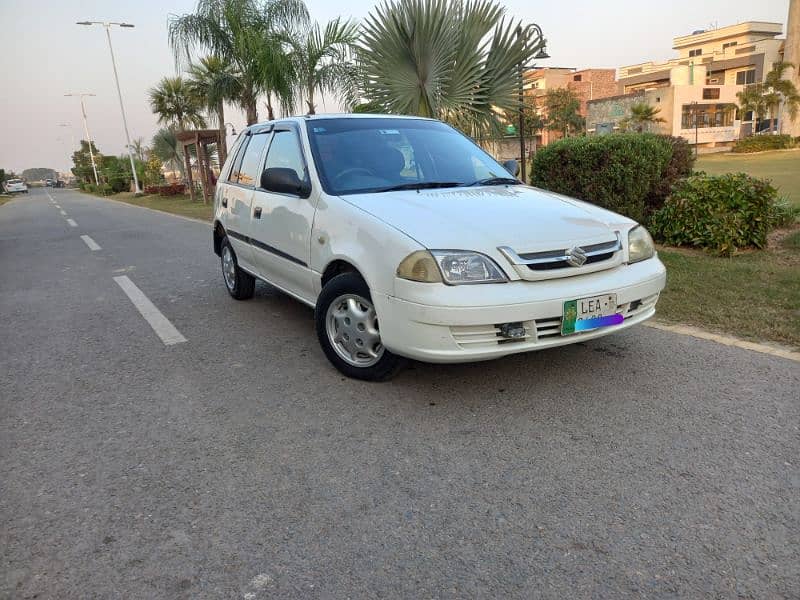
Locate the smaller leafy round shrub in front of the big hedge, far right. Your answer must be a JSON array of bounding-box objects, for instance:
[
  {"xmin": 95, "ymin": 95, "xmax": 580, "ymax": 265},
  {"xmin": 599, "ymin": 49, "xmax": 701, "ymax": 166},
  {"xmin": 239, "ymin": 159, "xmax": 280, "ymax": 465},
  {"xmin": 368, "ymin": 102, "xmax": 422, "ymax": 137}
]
[{"xmin": 650, "ymin": 173, "xmax": 778, "ymax": 256}]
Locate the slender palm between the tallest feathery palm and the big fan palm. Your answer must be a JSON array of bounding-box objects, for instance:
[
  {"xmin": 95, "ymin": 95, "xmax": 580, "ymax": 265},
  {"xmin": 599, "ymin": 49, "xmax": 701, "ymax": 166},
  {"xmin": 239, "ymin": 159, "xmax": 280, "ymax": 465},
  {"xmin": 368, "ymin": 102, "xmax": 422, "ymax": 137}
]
[{"xmin": 287, "ymin": 18, "xmax": 358, "ymax": 115}]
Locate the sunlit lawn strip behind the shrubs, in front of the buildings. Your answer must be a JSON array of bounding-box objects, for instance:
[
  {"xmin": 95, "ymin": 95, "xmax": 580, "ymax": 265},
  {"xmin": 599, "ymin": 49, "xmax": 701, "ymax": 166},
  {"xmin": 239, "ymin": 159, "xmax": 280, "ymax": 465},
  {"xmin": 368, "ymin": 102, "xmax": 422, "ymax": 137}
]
[{"xmin": 695, "ymin": 149, "xmax": 800, "ymax": 207}]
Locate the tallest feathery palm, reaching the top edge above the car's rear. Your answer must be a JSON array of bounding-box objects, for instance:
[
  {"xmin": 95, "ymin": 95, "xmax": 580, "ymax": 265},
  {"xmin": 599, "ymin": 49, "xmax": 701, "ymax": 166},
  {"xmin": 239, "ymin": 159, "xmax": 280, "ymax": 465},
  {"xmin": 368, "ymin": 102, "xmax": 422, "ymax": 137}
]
[{"xmin": 169, "ymin": 0, "xmax": 308, "ymax": 125}]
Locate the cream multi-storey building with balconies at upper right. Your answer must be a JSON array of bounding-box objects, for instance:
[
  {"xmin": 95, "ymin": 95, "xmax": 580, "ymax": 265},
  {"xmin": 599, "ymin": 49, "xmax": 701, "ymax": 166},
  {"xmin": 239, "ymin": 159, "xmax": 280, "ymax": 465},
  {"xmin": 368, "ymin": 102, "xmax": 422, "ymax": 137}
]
[{"xmin": 586, "ymin": 22, "xmax": 794, "ymax": 148}]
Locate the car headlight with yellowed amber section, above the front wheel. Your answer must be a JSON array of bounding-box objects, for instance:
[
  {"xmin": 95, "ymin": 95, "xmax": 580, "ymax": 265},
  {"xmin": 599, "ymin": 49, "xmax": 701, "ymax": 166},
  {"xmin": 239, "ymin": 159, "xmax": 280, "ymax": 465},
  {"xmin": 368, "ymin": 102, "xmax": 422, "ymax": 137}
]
[{"xmin": 397, "ymin": 250, "xmax": 508, "ymax": 285}]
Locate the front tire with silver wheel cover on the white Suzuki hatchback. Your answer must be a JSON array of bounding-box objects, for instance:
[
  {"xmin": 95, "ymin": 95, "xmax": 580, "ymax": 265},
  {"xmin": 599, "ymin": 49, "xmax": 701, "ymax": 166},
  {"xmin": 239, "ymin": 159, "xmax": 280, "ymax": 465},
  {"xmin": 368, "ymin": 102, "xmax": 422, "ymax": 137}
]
[{"xmin": 314, "ymin": 273, "xmax": 406, "ymax": 381}]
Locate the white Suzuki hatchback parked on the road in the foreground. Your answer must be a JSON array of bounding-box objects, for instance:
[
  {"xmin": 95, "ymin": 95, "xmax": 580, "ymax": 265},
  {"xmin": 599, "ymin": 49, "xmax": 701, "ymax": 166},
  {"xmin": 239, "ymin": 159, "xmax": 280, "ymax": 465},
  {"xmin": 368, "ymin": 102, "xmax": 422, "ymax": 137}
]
[{"xmin": 213, "ymin": 115, "xmax": 666, "ymax": 380}]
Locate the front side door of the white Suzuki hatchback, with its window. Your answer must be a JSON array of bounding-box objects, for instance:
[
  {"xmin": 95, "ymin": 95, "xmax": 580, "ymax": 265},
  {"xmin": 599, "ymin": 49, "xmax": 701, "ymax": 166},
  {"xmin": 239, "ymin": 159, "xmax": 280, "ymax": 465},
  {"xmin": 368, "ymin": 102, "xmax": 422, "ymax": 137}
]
[{"xmin": 250, "ymin": 125, "xmax": 315, "ymax": 302}]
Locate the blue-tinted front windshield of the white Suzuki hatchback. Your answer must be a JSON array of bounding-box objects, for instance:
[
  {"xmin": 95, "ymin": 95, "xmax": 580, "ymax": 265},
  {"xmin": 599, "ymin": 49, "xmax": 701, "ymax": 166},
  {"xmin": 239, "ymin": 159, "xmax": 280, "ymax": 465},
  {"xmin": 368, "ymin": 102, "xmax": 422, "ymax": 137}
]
[{"xmin": 308, "ymin": 117, "xmax": 517, "ymax": 195}]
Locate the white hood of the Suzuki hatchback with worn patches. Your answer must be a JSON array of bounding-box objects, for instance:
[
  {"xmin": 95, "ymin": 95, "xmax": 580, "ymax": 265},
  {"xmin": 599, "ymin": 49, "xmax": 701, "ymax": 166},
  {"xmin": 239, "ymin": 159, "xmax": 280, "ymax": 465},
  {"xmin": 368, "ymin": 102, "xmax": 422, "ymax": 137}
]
[{"xmin": 342, "ymin": 185, "xmax": 635, "ymax": 253}]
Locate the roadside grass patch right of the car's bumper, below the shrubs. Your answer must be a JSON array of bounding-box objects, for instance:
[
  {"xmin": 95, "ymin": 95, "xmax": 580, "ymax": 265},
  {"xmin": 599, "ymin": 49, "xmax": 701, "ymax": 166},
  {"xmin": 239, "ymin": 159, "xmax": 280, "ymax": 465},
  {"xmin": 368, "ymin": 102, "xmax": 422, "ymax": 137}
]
[{"xmin": 658, "ymin": 241, "xmax": 800, "ymax": 348}]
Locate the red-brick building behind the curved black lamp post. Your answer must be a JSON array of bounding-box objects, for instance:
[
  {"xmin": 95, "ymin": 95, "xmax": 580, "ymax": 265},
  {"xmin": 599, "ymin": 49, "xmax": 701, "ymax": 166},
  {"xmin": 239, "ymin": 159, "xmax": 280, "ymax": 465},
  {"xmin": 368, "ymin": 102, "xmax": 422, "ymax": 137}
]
[{"xmin": 523, "ymin": 67, "xmax": 618, "ymax": 146}]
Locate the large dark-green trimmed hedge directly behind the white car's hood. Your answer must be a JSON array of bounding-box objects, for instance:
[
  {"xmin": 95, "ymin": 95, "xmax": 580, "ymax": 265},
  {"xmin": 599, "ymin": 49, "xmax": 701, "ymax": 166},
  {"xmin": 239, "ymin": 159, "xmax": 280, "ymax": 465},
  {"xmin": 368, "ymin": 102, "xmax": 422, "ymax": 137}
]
[{"xmin": 531, "ymin": 133, "xmax": 694, "ymax": 221}]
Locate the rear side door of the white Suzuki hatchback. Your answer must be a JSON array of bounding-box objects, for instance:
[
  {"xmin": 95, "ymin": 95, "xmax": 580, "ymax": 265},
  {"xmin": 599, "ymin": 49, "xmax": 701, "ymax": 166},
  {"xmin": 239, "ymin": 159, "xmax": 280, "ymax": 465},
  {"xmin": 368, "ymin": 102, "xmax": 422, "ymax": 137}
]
[{"xmin": 221, "ymin": 131, "xmax": 269, "ymax": 272}]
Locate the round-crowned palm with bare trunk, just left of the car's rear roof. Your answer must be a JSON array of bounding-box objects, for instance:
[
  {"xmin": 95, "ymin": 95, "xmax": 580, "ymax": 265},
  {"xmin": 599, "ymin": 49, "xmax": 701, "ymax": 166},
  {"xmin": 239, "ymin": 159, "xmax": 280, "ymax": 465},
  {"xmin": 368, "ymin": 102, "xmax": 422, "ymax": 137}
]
[{"xmin": 188, "ymin": 55, "xmax": 242, "ymax": 162}]
